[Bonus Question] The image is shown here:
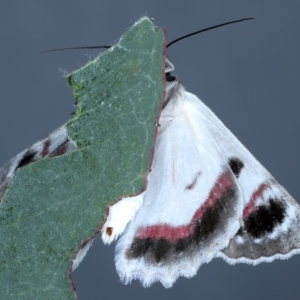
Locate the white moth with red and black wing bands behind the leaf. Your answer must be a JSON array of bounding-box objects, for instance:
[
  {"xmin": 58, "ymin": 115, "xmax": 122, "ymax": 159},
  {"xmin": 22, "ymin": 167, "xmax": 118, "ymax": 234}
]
[{"xmin": 0, "ymin": 18, "xmax": 300, "ymax": 287}]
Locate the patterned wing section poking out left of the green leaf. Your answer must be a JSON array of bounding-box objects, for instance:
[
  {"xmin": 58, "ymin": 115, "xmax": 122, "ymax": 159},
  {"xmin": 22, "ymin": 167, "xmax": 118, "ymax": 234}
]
[{"xmin": 0, "ymin": 126, "xmax": 76, "ymax": 202}]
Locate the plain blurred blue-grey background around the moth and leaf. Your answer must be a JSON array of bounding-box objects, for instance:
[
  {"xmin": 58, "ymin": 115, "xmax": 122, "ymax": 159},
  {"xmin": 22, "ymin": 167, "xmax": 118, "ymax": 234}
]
[{"xmin": 0, "ymin": 0, "xmax": 300, "ymax": 300}]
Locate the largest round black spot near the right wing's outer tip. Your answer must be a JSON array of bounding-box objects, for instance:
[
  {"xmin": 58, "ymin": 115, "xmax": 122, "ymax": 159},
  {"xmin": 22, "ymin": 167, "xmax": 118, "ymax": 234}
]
[{"xmin": 244, "ymin": 199, "xmax": 285, "ymax": 238}]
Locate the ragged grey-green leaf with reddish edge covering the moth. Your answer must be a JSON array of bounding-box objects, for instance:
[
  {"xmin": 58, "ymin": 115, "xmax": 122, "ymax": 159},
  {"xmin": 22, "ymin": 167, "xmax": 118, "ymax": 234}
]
[{"xmin": 0, "ymin": 18, "xmax": 164, "ymax": 299}]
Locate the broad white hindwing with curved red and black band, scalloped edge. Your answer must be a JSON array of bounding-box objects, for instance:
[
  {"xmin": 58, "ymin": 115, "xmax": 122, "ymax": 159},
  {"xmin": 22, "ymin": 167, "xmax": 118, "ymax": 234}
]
[{"xmin": 109, "ymin": 90, "xmax": 243, "ymax": 287}]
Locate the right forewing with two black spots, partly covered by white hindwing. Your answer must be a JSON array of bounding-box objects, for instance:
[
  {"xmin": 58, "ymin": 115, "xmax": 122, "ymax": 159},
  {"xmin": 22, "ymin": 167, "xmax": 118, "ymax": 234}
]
[{"xmin": 193, "ymin": 92, "xmax": 300, "ymax": 265}]
